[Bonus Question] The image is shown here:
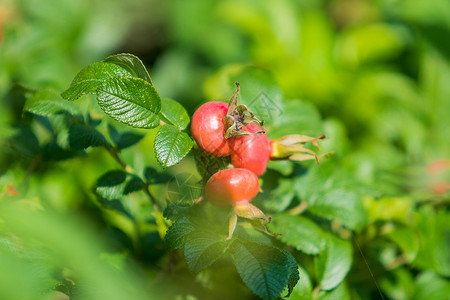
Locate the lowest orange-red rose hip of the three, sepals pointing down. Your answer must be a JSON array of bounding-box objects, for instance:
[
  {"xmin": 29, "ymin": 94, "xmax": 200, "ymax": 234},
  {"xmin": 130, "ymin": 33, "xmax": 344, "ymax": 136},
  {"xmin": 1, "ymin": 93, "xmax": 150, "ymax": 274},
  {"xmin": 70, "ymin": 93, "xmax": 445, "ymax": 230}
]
[{"xmin": 205, "ymin": 168, "xmax": 259, "ymax": 208}]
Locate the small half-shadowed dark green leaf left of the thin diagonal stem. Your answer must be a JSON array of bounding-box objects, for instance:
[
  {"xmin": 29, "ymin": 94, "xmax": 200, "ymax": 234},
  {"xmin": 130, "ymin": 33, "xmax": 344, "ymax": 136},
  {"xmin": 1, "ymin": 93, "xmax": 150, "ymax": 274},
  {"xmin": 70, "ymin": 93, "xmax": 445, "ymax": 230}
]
[{"xmin": 95, "ymin": 170, "xmax": 145, "ymax": 200}]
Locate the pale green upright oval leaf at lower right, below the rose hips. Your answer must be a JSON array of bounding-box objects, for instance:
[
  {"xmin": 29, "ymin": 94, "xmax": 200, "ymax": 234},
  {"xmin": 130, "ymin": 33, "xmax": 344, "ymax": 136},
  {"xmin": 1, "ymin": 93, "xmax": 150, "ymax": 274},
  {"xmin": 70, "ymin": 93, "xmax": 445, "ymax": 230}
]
[{"xmin": 315, "ymin": 234, "xmax": 353, "ymax": 291}]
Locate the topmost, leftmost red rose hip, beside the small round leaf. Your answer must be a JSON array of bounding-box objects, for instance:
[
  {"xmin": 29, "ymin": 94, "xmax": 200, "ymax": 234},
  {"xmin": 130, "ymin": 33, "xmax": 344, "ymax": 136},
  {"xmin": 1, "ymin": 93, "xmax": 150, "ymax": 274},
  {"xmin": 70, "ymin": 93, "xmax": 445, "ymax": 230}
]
[{"xmin": 191, "ymin": 101, "xmax": 231, "ymax": 157}]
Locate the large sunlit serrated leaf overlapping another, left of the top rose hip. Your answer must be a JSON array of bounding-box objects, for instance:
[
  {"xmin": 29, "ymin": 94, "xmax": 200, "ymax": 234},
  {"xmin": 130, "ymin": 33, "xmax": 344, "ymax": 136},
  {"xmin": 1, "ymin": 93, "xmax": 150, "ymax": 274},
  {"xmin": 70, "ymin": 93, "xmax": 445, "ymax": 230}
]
[{"xmin": 97, "ymin": 77, "xmax": 161, "ymax": 128}]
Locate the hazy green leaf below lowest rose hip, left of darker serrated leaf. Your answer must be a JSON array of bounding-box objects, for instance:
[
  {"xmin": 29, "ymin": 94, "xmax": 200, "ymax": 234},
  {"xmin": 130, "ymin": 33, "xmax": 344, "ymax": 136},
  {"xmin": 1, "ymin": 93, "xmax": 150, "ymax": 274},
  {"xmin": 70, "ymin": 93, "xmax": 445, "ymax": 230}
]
[{"xmin": 184, "ymin": 231, "xmax": 231, "ymax": 272}]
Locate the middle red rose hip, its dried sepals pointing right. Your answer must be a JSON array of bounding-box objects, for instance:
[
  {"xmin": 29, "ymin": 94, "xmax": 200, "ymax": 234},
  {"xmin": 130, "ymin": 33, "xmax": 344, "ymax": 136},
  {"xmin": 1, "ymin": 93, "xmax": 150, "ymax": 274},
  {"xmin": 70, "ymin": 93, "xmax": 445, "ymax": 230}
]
[{"xmin": 229, "ymin": 124, "xmax": 272, "ymax": 176}]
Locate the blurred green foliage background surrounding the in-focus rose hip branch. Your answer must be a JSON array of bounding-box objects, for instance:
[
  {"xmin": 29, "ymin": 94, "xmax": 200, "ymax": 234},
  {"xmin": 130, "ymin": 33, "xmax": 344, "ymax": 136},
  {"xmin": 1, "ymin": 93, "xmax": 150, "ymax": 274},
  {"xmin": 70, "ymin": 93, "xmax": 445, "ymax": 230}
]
[{"xmin": 0, "ymin": 0, "xmax": 450, "ymax": 300}]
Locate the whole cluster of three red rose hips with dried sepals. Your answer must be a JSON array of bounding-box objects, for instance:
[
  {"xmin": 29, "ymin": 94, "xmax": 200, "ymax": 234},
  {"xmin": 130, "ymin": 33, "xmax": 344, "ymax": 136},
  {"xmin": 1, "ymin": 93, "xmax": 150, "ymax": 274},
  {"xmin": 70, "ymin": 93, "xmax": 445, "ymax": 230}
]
[{"xmin": 191, "ymin": 83, "xmax": 325, "ymax": 237}]
